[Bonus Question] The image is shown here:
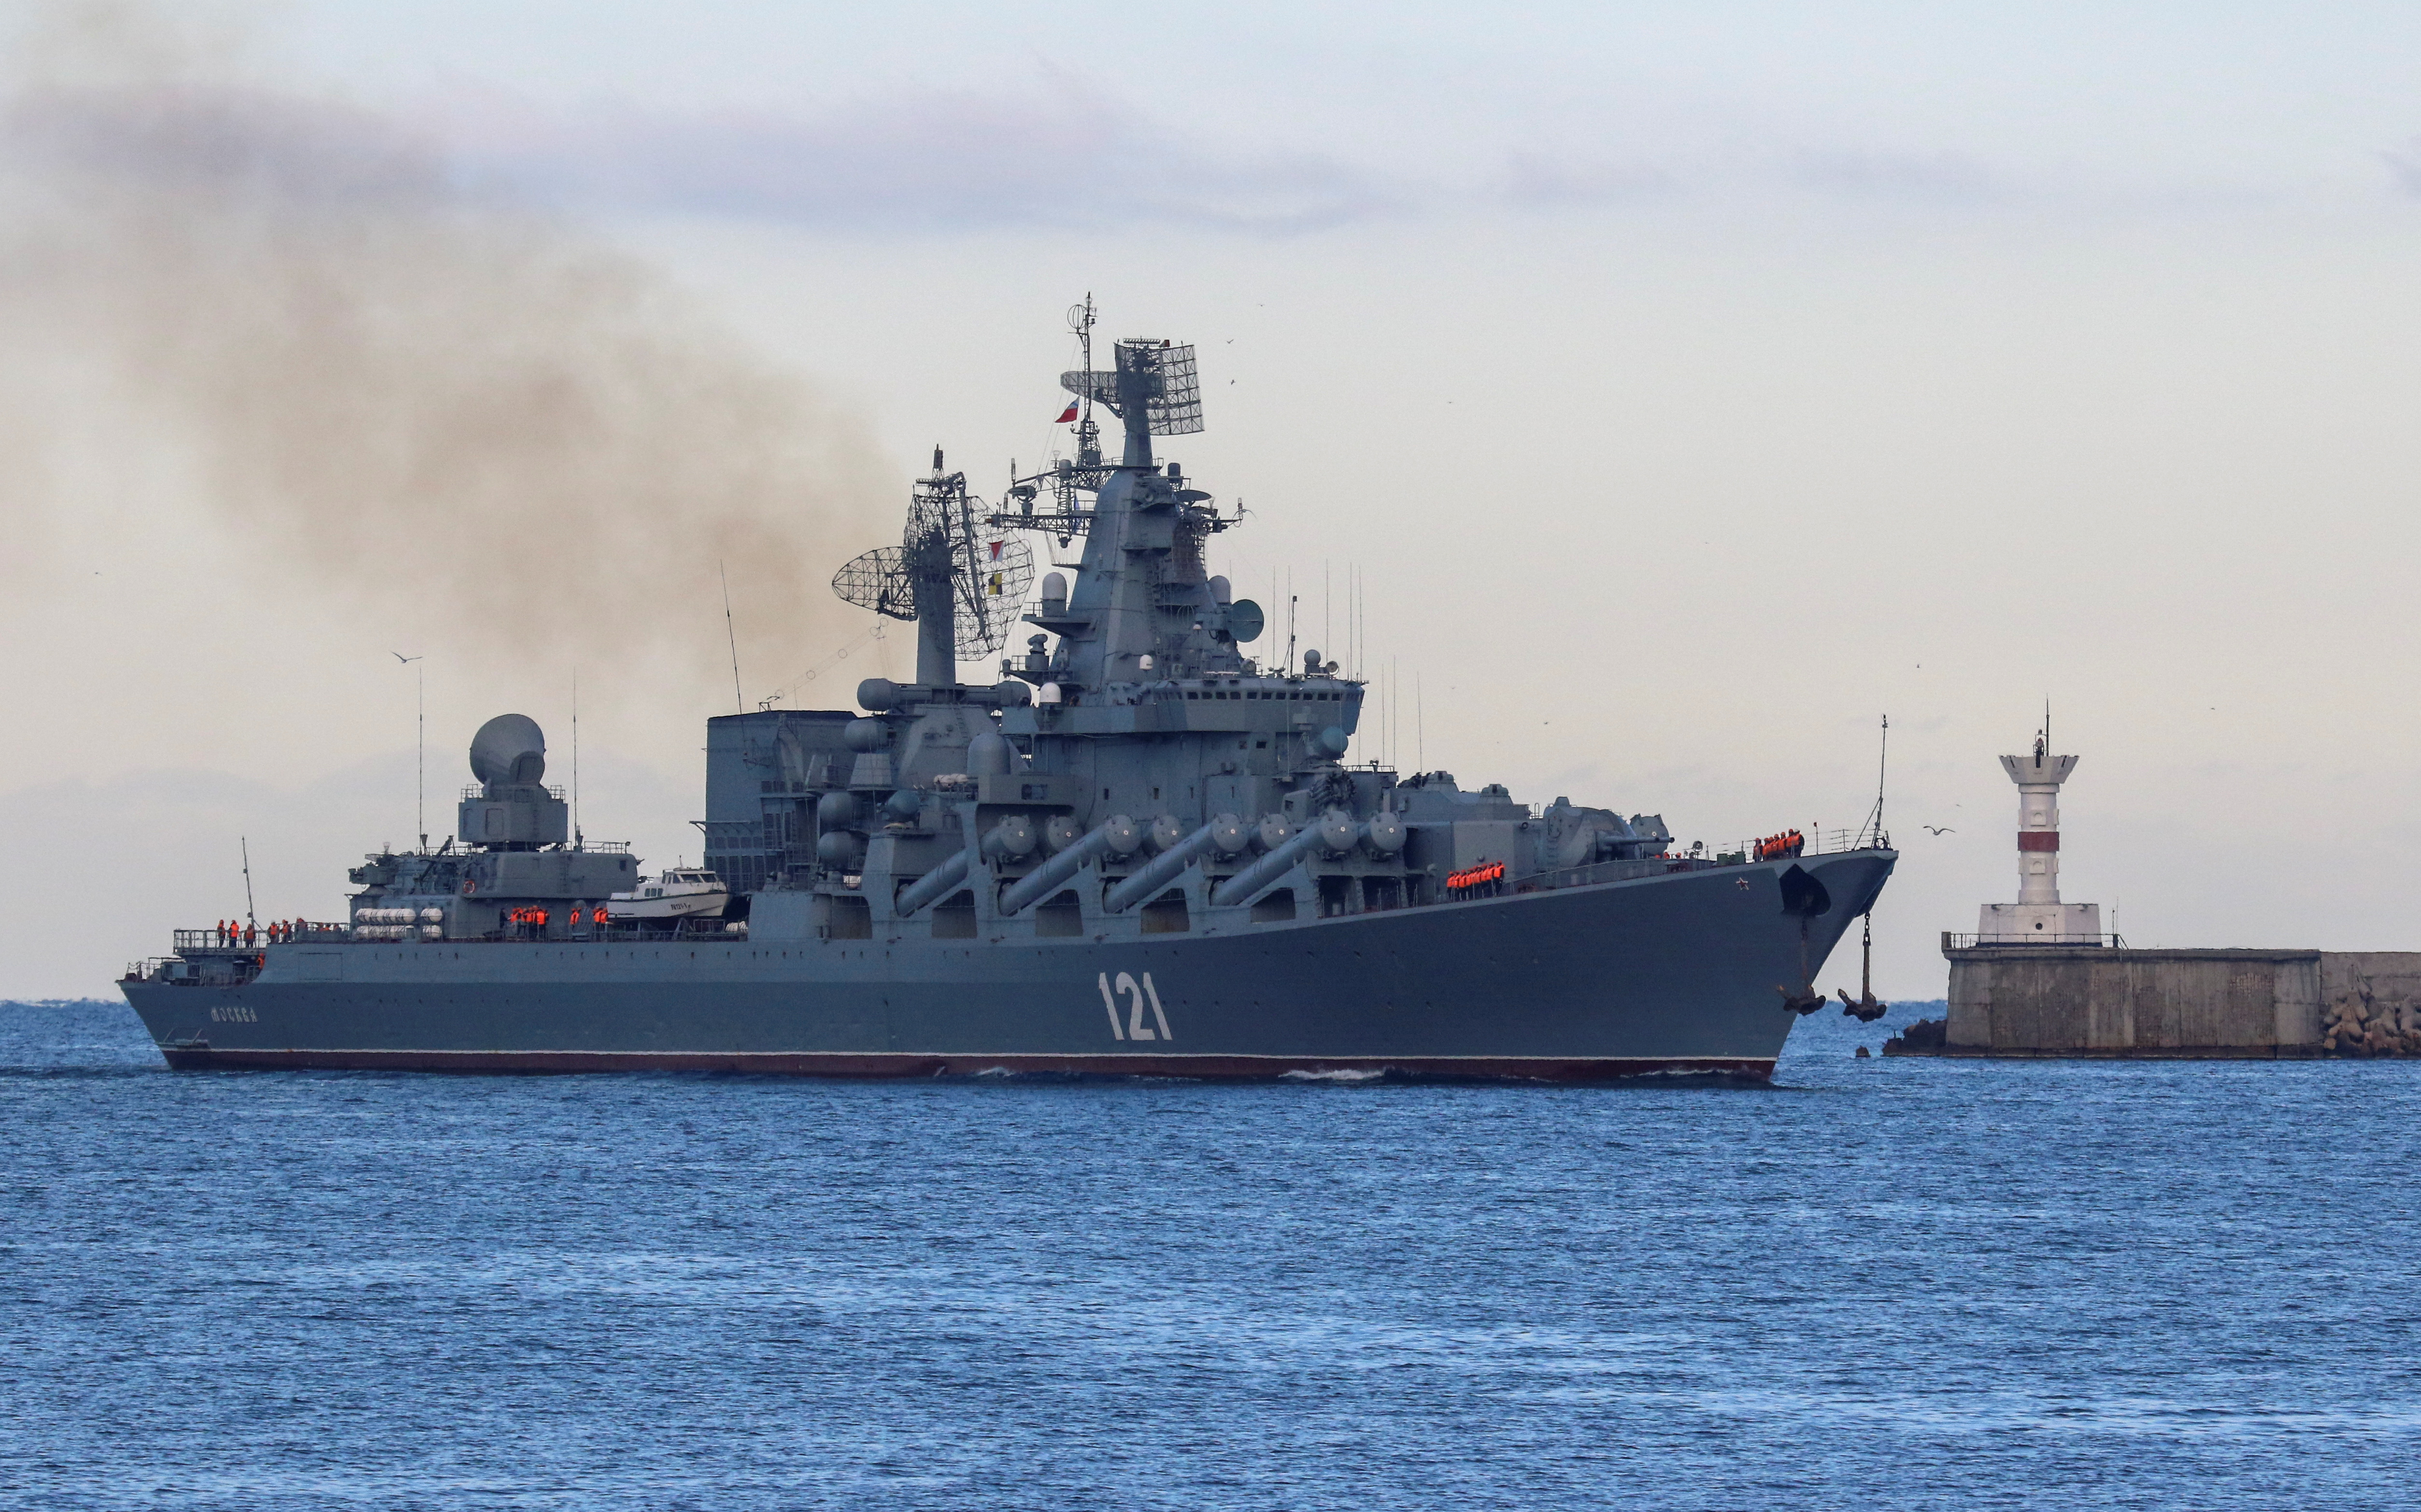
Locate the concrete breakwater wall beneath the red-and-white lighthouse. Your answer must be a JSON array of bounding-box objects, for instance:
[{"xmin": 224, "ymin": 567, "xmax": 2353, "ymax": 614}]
[{"xmin": 1883, "ymin": 936, "xmax": 2421, "ymax": 1059}]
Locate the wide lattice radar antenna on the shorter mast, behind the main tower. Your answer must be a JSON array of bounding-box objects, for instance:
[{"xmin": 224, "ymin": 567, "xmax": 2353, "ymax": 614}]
[{"xmin": 833, "ymin": 448, "xmax": 1034, "ymax": 658}]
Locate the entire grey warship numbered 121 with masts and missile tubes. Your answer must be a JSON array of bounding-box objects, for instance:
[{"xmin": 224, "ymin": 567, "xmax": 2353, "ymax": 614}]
[{"xmin": 121, "ymin": 298, "xmax": 1895, "ymax": 1081}]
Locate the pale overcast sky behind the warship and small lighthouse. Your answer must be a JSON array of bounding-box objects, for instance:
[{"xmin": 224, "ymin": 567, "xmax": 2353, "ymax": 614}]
[{"xmin": 0, "ymin": 0, "xmax": 2421, "ymax": 997}]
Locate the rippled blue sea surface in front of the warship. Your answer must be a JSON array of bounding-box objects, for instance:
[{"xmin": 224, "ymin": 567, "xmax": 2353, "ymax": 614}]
[{"xmin": 0, "ymin": 1004, "xmax": 2421, "ymax": 1510}]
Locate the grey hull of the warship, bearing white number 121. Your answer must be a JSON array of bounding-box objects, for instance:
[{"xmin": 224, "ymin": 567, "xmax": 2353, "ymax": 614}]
[{"xmin": 124, "ymin": 849, "xmax": 1895, "ymax": 1081}]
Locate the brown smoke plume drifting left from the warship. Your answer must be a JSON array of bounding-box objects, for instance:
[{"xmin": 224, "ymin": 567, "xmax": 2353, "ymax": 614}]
[{"xmin": 0, "ymin": 5, "xmax": 900, "ymax": 692}]
